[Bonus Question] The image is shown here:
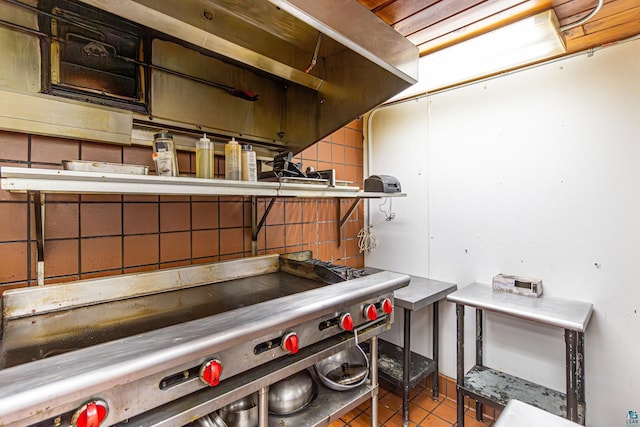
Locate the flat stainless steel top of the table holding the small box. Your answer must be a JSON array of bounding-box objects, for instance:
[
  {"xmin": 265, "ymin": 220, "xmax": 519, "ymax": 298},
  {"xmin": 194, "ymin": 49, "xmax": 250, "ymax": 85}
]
[{"xmin": 447, "ymin": 283, "xmax": 593, "ymax": 332}]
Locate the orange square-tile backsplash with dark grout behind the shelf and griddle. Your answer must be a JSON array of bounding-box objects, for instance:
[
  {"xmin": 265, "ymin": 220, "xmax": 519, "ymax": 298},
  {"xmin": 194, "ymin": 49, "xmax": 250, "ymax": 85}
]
[{"xmin": 0, "ymin": 120, "xmax": 364, "ymax": 294}]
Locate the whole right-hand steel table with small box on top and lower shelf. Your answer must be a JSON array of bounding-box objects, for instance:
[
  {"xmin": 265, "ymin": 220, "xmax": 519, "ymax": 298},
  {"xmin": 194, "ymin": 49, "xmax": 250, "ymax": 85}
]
[{"xmin": 447, "ymin": 283, "xmax": 593, "ymax": 427}]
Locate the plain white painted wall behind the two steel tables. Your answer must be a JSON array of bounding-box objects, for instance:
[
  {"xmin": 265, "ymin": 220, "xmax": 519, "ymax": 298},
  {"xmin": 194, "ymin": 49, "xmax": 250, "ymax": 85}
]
[{"xmin": 366, "ymin": 40, "xmax": 640, "ymax": 427}]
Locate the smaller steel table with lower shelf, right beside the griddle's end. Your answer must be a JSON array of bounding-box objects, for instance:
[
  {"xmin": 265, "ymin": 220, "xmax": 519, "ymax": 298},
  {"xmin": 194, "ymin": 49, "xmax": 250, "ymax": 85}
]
[{"xmin": 378, "ymin": 276, "xmax": 457, "ymax": 426}]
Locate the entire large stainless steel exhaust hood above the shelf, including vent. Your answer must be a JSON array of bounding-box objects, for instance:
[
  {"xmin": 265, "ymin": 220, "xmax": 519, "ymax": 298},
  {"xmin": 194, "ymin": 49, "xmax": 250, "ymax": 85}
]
[{"xmin": 0, "ymin": 0, "xmax": 418, "ymax": 155}]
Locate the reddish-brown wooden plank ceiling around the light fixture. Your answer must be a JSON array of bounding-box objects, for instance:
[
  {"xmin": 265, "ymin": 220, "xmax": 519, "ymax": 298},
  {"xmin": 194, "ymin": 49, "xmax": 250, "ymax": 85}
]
[{"xmin": 358, "ymin": 0, "xmax": 640, "ymax": 56}]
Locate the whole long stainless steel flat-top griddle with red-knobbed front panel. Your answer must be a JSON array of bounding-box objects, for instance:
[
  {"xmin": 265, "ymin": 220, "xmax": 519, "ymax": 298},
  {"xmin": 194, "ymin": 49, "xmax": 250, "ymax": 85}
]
[{"xmin": 0, "ymin": 254, "xmax": 410, "ymax": 426}]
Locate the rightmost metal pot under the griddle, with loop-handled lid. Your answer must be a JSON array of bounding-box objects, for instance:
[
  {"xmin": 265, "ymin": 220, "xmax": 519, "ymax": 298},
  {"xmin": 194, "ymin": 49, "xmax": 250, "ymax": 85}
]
[{"xmin": 314, "ymin": 345, "xmax": 369, "ymax": 391}]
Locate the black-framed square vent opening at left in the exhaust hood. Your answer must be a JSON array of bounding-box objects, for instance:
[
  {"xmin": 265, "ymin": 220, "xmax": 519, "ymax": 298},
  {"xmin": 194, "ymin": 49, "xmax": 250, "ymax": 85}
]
[{"xmin": 33, "ymin": 0, "xmax": 148, "ymax": 113}]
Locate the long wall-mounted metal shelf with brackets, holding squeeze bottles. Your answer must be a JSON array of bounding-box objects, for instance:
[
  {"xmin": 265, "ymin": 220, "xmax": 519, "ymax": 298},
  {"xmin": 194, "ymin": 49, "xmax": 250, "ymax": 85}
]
[{"xmin": 0, "ymin": 166, "xmax": 406, "ymax": 285}]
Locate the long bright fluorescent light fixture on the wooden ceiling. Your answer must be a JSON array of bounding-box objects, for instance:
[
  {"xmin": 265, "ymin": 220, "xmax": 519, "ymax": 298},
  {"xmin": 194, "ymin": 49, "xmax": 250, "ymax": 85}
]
[{"xmin": 394, "ymin": 10, "xmax": 566, "ymax": 99}]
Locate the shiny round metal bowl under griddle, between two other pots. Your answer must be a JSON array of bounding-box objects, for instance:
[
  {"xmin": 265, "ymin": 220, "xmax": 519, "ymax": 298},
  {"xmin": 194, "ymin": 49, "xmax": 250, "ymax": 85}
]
[{"xmin": 269, "ymin": 369, "xmax": 318, "ymax": 415}]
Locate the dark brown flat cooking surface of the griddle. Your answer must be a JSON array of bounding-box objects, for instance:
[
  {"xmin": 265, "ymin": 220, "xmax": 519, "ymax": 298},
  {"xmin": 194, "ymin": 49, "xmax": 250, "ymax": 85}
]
[{"xmin": 0, "ymin": 271, "xmax": 326, "ymax": 368}]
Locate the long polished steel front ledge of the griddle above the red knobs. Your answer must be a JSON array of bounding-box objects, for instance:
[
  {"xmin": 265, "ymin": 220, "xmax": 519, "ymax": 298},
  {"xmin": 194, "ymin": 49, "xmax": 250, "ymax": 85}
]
[{"xmin": 0, "ymin": 272, "xmax": 410, "ymax": 424}]
